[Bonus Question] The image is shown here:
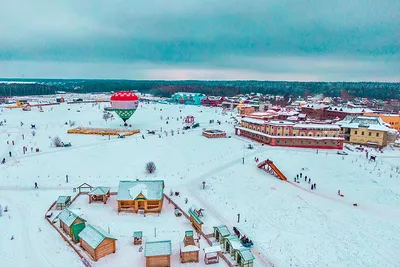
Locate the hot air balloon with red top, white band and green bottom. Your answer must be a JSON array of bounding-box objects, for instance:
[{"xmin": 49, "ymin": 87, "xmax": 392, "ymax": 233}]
[{"xmin": 110, "ymin": 91, "xmax": 139, "ymax": 126}]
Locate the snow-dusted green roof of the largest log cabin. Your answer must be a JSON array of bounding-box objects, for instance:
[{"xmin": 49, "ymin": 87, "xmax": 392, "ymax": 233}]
[{"xmin": 117, "ymin": 180, "xmax": 164, "ymax": 200}]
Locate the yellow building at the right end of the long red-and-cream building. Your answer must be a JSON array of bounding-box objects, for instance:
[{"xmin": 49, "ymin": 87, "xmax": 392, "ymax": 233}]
[{"xmin": 338, "ymin": 116, "xmax": 390, "ymax": 147}]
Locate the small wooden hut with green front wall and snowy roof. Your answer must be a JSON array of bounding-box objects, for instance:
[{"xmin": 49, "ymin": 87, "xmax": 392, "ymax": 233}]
[{"xmin": 58, "ymin": 208, "xmax": 86, "ymax": 243}]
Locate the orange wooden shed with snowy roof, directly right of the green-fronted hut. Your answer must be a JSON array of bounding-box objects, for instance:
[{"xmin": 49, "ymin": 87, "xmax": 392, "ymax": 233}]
[{"xmin": 79, "ymin": 224, "xmax": 117, "ymax": 261}]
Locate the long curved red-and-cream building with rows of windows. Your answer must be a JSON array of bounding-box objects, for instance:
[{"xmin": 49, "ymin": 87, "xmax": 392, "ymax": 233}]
[{"xmin": 235, "ymin": 118, "xmax": 344, "ymax": 149}]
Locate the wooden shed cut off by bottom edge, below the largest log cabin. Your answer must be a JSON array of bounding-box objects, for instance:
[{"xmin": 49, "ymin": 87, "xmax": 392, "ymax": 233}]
[{"xmin": 144, "ymin": 240, "xmax": 172, "ymax": 267}]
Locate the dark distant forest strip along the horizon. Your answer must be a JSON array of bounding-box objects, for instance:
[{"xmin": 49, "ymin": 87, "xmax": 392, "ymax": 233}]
[{"xmin": 0, "ymin": 79, "xmax": 400, "ymax": 99}]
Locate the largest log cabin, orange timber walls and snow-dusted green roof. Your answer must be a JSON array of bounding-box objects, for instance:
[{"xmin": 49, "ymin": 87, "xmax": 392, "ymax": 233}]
[{"xmin": 117, "ymin": 180, "xmax": 164, "ymax": 213}]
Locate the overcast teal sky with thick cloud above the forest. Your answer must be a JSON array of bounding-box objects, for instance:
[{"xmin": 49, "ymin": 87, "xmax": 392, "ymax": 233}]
[{"xmin": 0, "ymin": 0, "xmax": 400, "ymax": 81}]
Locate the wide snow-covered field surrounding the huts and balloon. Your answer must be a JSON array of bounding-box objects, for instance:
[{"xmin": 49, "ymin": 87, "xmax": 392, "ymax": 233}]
[{"xmin": 0, "ymin": 99, "xmax": 400, "ymax": 266}]
